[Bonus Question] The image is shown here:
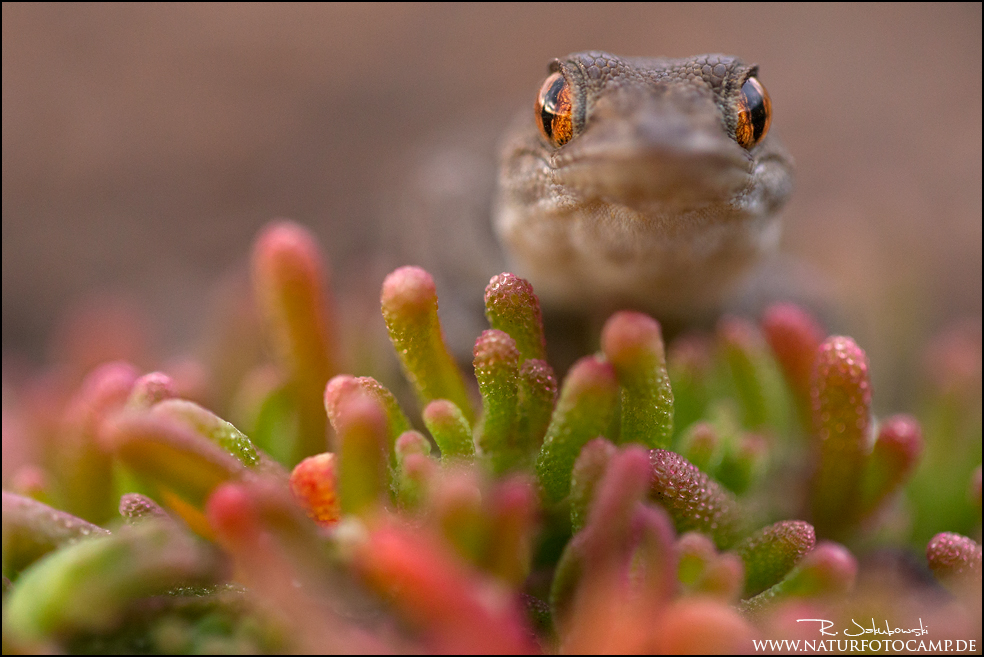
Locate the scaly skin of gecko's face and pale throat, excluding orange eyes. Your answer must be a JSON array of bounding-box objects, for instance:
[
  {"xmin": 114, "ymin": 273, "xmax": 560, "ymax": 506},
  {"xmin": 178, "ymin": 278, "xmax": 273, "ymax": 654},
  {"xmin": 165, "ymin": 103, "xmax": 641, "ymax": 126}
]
[{"xmin": 493, "ymin": 52, "xmax": 792, "ymax": 319}]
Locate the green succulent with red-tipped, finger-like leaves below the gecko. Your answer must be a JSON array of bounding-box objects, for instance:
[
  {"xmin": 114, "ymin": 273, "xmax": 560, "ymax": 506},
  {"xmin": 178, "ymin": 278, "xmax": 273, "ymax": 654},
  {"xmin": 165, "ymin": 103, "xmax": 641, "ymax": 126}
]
[{"xmin": 3, "ymin": 222, "xmax": 982, "ymax": 653}]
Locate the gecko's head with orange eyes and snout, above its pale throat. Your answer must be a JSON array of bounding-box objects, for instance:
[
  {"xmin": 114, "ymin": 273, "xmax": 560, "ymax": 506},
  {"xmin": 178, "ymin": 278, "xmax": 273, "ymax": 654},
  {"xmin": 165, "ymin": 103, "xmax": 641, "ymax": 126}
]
[{"xmin": 535, "ymin": 53, "xmax": 790, "ymax": 216}]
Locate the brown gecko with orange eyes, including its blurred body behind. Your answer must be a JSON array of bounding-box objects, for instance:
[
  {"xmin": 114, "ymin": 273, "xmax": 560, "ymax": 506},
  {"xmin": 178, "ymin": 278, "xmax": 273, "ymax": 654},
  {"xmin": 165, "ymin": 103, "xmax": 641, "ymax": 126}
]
[{"xmin": 390, "ymin": 52, "xmax": 793, "ymax": 356}]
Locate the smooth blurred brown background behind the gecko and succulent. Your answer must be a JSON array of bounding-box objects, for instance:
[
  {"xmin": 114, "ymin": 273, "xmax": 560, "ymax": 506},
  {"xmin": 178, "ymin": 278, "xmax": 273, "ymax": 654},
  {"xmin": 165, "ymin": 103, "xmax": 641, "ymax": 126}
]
[{"xmin": 3, "ymin": 3, "xmax": 981, "ymax": 404}]
